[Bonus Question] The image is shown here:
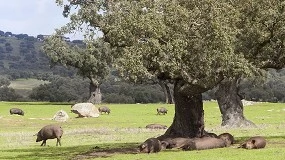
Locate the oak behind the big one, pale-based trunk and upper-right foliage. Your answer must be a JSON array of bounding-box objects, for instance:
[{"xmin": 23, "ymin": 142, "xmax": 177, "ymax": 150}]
[{"xmin": 216, "ymin": 0, "xmax": 285, "ymax": 127}]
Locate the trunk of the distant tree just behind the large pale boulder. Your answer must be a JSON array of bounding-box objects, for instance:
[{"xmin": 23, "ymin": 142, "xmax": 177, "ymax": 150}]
[{"xmin": 88, "ymin": 82, "xmax": 102, "ymax": 104}]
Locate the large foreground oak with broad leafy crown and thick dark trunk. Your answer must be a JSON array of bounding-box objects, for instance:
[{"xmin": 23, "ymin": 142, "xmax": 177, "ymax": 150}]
[{"xmin": 52, "ymin": 0, "xmax": 255, "ymax": 137}]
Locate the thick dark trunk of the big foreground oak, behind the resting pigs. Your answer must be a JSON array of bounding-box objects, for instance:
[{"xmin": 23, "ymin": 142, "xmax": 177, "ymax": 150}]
[{"xmin": 158, "ymin": 82, "xmax": 205, "ymax": 139}]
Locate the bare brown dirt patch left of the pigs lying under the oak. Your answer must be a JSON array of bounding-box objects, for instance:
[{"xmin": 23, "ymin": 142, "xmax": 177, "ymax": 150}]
[{"xmin": 73, "ymin": 146, "xmax": 139, "ymax": 160}]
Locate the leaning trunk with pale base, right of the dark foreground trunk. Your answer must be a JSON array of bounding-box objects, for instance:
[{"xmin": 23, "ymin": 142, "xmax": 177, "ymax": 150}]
[{"xmin": 215, "ymin": 78, "xmax": 255, "ymax": 128}]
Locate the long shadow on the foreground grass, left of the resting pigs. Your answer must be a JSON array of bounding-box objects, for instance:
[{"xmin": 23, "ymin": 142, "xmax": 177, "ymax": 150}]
[{"xmin": 0, "ymin": 143, "xmax": 139, "ymax": 160}]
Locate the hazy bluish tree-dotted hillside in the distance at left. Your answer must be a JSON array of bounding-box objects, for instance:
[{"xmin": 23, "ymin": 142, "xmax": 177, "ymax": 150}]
[{"xmin": 0, "ymin": 30, "xmax": 82, "ymax": 79}]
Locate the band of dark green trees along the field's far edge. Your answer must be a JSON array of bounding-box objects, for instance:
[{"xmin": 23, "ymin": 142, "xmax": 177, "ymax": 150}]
[{"xmin": 0, "ymin": 70, "xmax": 285, "ymax": 103}]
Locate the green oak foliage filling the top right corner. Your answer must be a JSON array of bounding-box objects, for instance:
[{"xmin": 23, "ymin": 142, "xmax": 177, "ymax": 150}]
[{"xmin": 237, "ymin": 0, "xmax": 285, "ymax": 69}]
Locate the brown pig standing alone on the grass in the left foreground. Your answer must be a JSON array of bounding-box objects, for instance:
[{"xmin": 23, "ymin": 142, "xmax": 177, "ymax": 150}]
[{"xmin": 36, "ymin": 124, "xmax": 63, "ymax": 146}]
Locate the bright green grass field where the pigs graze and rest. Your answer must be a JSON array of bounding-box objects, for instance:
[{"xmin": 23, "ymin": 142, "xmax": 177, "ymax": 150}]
[{"xmin": 0, "ymin": 102, "xmax": 285, "ymax": 160}]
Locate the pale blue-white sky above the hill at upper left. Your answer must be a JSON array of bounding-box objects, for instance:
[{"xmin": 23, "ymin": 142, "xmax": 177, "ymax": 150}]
[{"xmin": 0, "ymin": 0, "xmax": 82, "ymax": 39}]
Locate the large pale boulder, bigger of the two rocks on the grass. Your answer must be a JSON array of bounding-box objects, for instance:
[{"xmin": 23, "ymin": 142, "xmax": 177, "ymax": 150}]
[{"xmin": 71, "ymin": 103, "xmax": 100, "ymax": 117}]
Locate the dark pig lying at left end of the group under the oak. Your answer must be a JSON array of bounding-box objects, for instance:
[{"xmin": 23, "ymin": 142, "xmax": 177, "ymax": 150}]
[{"xmin": 139, "ymin": 138, "xmax": 162, "ymax": 153}]
